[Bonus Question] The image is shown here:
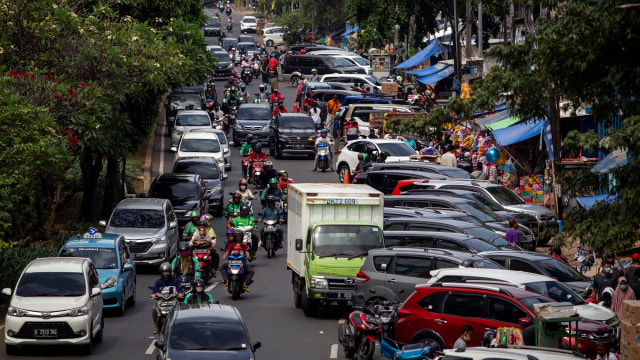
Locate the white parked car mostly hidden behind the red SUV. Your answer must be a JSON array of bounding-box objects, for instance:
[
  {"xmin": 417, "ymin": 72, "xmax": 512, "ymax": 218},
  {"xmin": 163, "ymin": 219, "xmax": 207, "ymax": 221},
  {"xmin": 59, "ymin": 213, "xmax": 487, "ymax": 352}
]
[{"xmin": 427, "ymin": 269, "xmax": 619, "ymax": 328}]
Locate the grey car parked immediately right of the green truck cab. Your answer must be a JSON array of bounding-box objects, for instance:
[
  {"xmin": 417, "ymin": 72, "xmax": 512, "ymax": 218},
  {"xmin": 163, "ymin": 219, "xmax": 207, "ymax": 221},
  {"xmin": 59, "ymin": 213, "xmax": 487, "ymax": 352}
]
[{"xmin": 353, "ymin": 247, "xmax": 501, "ymax": 305}]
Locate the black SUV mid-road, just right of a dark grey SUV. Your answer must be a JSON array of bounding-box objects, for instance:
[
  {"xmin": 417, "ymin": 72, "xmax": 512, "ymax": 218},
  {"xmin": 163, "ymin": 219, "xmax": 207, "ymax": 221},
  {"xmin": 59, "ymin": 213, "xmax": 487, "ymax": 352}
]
[{"xmin": 269, "ymin": 113, "xmax": 317, "ymax": 159}]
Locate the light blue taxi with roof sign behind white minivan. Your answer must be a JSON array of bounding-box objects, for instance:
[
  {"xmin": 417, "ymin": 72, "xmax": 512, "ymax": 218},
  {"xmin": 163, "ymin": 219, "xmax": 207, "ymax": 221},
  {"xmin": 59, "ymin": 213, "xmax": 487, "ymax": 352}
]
[{"xmin": 58, "ymin": 228, "xmax": 136, "ymax": 315}]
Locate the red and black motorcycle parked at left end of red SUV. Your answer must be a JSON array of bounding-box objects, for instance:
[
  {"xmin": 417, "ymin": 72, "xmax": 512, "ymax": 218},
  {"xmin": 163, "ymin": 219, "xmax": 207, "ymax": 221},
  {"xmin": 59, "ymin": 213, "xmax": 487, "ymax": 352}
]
[{"xmin": 338, "ymin": 302, "xmax": 397, "ymax": 360}]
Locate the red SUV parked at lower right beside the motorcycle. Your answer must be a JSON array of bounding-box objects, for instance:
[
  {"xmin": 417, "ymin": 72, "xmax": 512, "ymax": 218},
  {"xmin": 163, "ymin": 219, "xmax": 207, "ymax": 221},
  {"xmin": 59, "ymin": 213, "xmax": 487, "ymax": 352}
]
[{"xmin": 396, "ymin": 283, "xmax": 616, "ymax": 356}]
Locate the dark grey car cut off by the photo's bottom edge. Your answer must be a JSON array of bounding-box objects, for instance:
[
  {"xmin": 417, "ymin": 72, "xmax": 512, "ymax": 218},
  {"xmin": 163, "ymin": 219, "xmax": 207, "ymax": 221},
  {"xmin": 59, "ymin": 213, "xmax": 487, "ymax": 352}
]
[{"xmin": 154, "ymin": 304, "xmax": 261, "ymax": 359}]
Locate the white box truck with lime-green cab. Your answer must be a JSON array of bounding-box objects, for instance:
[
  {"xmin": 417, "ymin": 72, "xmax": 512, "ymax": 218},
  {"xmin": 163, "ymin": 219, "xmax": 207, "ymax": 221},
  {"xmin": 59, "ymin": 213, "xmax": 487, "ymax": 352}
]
[{"xmin": 287, "ymin": 183, "xmax": 384, "ymax": 316}]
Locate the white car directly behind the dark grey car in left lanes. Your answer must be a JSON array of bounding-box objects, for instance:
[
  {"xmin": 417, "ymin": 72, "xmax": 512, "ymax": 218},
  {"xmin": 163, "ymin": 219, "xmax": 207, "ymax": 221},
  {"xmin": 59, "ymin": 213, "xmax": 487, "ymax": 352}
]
[{"xmin": 174, "ymin": 130, "xmax": 225, "ymax": 173}]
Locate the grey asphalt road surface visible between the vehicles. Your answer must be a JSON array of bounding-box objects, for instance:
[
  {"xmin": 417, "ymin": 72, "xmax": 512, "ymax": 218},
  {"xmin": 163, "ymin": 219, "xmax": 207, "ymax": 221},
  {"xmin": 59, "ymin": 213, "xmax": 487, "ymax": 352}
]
[{"xmin": 0, "ymin": 5, "xmax": 362, "ymax": 360}]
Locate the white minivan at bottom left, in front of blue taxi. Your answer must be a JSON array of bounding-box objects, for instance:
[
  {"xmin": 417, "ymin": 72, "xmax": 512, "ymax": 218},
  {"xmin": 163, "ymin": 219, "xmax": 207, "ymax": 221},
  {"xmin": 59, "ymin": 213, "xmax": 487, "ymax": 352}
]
[{"xmin": 2, "ymin": 257, "xmax": 104, "ymax": 354}]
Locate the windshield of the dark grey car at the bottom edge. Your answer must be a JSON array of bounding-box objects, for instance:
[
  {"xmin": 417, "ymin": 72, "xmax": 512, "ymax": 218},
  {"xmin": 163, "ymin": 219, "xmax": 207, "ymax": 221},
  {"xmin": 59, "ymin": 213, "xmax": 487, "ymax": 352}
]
[{"xmin": 169, "ymin": 321, "xmax": 250, "ymax": 350}]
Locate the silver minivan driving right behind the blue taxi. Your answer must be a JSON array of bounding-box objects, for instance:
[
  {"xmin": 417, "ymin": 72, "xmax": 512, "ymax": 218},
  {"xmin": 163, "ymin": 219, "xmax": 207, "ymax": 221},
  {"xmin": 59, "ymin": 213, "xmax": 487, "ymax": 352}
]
[{"xmin": 100, "ymin": 198, "xmax": 179, "ymax": 265}]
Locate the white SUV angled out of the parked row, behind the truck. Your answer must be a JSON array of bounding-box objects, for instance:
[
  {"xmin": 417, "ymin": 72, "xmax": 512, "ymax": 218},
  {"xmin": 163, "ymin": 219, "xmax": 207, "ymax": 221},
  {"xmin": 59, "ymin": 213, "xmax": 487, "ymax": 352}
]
[{"xmin": 336, "ymin": 139, "xmax": 417, "ymax": 182}]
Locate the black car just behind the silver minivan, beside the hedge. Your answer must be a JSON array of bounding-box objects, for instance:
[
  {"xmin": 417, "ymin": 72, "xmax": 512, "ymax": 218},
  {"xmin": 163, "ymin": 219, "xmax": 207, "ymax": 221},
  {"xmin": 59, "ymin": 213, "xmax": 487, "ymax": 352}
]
[{"xmin": 149, "ymin": 173, "xmax": 209, "ymax": 226}]
